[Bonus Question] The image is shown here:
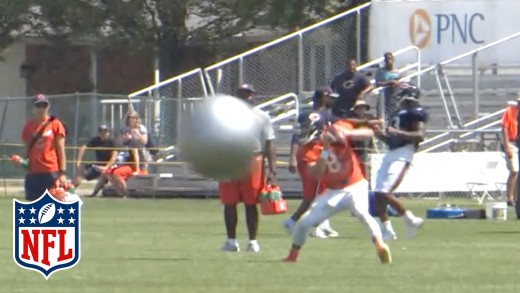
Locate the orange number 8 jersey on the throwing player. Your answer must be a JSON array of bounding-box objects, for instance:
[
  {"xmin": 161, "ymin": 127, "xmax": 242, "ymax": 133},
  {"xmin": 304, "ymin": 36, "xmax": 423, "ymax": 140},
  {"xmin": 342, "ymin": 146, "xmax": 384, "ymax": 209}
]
[{"xmin": 301, "ymin": 121, "xmax": 364, "ymax": 189}]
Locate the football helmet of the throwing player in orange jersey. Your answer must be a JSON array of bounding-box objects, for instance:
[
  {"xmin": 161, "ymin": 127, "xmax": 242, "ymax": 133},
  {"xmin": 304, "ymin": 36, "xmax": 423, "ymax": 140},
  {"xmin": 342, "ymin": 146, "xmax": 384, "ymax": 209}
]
[{"xmin": 296, "ymin": 111, "xmax": 334, "ymax": 144}]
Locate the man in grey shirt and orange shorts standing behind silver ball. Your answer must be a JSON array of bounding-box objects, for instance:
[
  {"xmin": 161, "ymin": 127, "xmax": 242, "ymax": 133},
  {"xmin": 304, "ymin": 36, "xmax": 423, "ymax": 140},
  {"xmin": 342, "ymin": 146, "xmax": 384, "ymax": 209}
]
[{"xmin": 219, "ymin": 84, "xmax": 276, "ymax": 252}]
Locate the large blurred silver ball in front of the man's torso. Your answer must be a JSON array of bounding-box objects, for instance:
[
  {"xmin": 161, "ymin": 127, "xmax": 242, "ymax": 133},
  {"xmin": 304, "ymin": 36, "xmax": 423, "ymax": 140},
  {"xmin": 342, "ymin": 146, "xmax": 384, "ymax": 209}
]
[{"xmin": 181, "ymin": 95, "xmax": 260, "ymax": 180}]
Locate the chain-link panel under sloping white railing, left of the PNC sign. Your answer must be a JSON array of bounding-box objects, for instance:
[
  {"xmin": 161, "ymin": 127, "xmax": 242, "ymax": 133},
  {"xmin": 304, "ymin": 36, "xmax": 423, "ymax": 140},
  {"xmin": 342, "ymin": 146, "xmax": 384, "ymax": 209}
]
[{"xmin": 205, "ymin": 3, "xmax": 370, "ymax": 98}]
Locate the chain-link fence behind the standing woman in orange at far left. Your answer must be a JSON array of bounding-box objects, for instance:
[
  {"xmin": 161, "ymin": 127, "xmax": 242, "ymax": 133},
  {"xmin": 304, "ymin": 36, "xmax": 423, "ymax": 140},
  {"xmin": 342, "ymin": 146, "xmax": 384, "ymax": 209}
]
[{"xmin": 0, "ymin": 93, "xmax": 152, "ymax": 178}]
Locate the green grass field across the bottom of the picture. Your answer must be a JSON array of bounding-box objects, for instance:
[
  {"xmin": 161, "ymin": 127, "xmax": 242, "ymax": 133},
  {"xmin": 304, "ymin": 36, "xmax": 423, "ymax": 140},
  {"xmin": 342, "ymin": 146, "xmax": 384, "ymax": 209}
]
[{"xmin": 0, "ymin": 198, "xmax": 520, "ymax": 293}]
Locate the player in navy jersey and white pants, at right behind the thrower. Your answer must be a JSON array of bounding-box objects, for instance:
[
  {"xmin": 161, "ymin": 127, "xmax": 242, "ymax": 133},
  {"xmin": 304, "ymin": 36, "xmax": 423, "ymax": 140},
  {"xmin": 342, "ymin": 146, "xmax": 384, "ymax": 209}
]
[{"xmin": 374, "ymin": 84, "xmax": 428, "ymax": 239}]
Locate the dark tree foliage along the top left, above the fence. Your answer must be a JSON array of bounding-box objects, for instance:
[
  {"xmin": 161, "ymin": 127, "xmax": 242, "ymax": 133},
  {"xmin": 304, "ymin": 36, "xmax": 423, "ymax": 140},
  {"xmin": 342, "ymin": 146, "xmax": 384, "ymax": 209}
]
[{"xmin": 0, "ymin": 0, "xmax": 350, "ymax": 74}]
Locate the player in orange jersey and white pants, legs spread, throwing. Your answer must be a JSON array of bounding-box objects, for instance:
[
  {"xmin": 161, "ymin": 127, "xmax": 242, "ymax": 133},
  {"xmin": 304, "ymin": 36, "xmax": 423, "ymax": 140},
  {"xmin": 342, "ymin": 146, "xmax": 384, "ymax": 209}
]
[{"xmin": 284, "ymin": 112, "xmax": 392, "ymax": 263}]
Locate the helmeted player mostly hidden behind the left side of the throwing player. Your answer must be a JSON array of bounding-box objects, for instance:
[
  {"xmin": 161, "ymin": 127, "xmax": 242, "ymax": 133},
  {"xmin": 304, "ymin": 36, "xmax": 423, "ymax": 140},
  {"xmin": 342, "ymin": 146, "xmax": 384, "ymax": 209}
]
[{"xmin": 283, "ymin": 87, "xmax": 339, "ymax": 238}]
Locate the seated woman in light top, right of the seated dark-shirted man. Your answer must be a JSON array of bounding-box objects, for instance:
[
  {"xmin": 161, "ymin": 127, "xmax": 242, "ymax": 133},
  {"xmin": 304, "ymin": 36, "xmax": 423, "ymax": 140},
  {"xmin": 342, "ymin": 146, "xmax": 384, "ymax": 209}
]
[{"xmin": 120, "ymin": 110, "xmax": 151, "ymax": 174}]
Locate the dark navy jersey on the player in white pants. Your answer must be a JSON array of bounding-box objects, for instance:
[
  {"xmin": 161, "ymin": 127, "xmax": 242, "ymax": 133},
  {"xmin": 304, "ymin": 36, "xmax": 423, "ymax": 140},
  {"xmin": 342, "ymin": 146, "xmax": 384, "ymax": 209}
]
[{"xmin": 386, "ymin": 106, "xmax": 428, "ymax": 150}]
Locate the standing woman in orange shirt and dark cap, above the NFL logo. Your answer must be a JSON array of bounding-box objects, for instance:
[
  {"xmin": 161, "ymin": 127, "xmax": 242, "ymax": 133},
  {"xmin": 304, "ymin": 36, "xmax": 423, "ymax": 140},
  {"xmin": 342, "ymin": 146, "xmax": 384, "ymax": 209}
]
[{"xmin": 22, "ymin": 94, "xmax": 67, "ymax": 201}]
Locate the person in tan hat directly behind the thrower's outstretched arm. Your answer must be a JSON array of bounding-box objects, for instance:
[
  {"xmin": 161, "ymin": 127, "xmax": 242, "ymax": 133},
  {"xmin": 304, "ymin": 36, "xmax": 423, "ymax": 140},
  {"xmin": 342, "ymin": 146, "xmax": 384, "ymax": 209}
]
[{"xmin": 347, "ymin": 100, "xmax": 377, "ymax": 179}]
